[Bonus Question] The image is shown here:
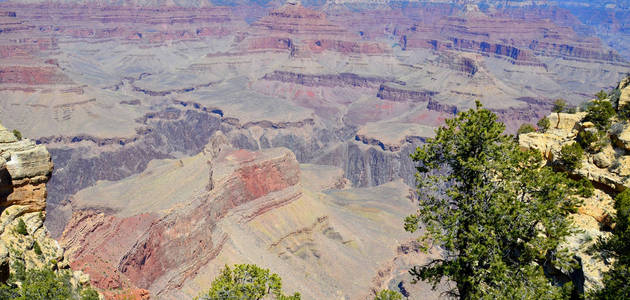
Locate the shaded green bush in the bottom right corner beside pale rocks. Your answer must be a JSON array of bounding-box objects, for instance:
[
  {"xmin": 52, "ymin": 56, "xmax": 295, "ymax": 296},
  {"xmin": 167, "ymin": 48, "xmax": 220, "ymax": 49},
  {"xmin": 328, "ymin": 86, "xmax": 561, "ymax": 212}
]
[{"xmin": 591, "ymin": 189, "xmax": 630, "ymax": 300}]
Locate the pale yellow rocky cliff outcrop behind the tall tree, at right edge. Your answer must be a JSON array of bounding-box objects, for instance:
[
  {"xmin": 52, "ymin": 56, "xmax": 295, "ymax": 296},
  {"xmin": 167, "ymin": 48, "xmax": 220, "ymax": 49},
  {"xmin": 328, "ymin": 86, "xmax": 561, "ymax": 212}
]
[{"xmin": 519, "ymin": 78, "xmax": 630, "ymax": 290}]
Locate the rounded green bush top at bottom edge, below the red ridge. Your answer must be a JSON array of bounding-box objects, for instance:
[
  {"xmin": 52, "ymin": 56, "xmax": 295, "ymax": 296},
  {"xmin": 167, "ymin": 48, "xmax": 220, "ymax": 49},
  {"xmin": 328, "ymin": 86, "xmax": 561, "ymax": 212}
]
[{"xmin": 196, "ymin": 264, "xmax": 300, "ymax": 300}]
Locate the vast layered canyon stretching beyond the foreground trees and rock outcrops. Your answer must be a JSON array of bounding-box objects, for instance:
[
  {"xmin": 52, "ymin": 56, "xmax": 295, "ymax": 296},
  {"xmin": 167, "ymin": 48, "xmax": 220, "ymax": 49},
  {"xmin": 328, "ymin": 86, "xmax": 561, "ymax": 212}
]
[{"xmin": 0, "ymin": 0, "xmax": 630, "ymax": 299}]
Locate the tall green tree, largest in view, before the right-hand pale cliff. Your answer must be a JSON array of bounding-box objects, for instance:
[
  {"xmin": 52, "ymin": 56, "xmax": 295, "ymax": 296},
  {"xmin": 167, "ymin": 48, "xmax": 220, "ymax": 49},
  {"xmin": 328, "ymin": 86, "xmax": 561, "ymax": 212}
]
[{"xmin": 405, "ymin": 103, "xmax": 579, "ymax": 299}]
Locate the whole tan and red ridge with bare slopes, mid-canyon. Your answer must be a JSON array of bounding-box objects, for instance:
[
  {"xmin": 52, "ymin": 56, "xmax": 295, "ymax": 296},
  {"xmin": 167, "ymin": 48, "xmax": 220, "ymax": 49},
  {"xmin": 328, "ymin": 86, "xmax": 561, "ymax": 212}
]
[{"xmin": 61, "ymin": 132, "xmax": 434, "ymax": 299}]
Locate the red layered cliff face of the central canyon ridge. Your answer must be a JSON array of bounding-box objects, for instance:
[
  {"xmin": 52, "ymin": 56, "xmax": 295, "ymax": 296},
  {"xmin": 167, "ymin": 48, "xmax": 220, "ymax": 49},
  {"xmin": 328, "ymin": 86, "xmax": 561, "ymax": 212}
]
[{"xmin": 61, "ymin": 149, "xmax": 299, "ymax": 293}]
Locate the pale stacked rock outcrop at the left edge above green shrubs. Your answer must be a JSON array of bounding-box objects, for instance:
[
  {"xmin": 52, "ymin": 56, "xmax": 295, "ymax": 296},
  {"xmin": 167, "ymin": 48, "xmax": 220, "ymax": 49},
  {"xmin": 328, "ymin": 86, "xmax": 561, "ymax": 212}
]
[{"xmin": 0, "ymin": 125, "xmax": 89, "ymax": 286}]
